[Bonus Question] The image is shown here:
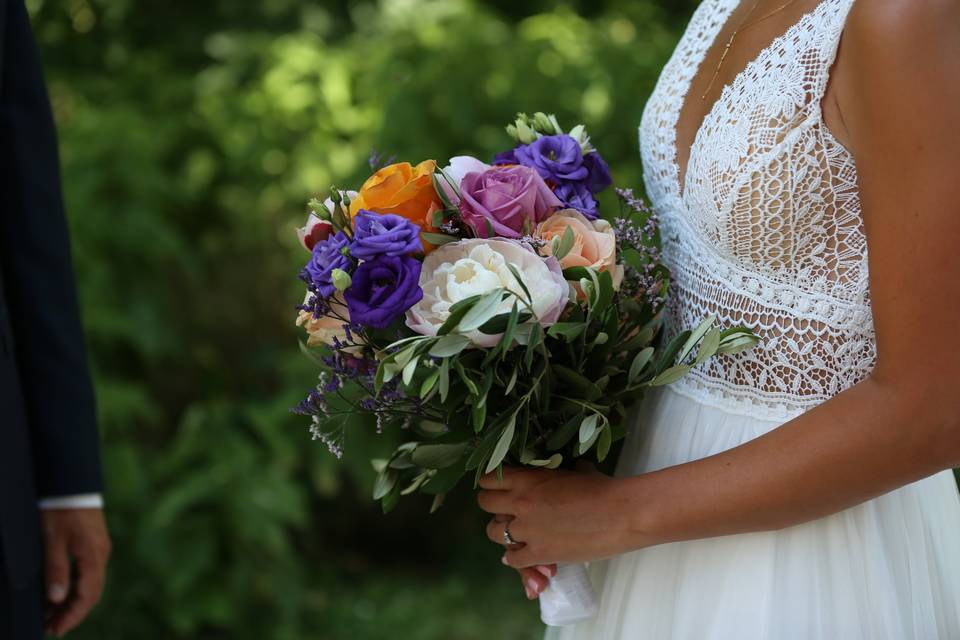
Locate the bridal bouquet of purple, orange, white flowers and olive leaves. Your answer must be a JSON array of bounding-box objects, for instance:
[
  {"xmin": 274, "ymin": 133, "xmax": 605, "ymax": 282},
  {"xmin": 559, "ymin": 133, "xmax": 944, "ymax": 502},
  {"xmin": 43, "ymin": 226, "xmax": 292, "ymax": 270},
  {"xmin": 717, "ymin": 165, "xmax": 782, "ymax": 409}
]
[{"xmin": 294, "ymin": 113, "xmax": 756, "ymax": 618}]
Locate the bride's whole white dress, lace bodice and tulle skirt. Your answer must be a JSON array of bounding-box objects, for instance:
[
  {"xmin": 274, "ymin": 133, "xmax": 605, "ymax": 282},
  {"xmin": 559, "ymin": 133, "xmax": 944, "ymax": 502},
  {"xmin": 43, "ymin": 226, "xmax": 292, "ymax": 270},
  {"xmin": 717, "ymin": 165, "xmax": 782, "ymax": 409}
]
[{"xmin": 548, "ymin": 0, "xmax": 960, "ymax": 640}]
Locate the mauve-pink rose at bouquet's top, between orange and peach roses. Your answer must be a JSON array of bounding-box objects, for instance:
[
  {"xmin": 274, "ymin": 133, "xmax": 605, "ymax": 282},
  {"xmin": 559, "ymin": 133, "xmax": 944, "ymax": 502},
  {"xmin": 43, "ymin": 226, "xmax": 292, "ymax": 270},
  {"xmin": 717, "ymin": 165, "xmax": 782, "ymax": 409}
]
[{"xmin": 460, "ymin": 166, "xmax": 563, "ymax": 238}]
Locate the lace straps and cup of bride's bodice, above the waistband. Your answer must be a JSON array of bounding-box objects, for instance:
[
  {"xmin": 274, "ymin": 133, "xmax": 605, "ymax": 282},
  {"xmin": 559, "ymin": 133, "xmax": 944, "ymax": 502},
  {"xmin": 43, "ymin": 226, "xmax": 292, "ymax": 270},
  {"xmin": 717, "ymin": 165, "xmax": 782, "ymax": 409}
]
[{"xmin": 640, "ymin": 0, "xmax": 866, "ymax": 289}]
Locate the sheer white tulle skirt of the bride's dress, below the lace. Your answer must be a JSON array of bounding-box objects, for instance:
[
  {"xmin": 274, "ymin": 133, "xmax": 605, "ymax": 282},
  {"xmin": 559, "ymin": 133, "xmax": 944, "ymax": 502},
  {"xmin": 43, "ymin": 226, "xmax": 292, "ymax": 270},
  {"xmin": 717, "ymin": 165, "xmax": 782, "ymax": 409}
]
[{"xmin": 547, "ymin": 389, "xmax": 960, "ymax": 640}]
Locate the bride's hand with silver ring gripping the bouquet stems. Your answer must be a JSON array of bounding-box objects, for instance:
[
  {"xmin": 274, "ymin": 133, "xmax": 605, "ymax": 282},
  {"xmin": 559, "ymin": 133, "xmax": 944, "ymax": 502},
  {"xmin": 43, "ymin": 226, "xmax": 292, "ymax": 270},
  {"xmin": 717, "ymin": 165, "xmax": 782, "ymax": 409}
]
[{"xmin": 477, "ymin": 464, "xmax": 648, "ymax": 568}]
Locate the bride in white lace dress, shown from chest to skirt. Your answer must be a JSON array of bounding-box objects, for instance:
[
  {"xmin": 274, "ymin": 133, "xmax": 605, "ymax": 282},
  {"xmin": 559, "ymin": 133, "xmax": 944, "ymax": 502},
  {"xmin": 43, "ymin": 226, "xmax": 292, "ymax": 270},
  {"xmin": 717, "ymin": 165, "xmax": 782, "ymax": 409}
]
[{"xmin": 479, "ymin": 0, "xmax": 960, "ymax": 640}]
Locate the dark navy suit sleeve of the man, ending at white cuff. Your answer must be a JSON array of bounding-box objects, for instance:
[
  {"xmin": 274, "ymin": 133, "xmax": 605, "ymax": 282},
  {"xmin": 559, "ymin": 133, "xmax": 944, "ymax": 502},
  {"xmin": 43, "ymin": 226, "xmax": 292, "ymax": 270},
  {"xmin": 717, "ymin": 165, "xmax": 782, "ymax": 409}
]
[{"xmin": 0, "ymin": 0, "xmax": 102, "ymax": 497}]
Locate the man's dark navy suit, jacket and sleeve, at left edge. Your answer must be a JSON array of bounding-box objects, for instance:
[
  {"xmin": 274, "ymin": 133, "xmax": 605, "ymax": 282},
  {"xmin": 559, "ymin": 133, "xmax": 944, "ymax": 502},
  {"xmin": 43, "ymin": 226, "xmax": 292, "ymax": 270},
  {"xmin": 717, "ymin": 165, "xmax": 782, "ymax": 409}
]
[{"xmin": 0, "ymin": 0, "xmax": 101, "ymax": 640}]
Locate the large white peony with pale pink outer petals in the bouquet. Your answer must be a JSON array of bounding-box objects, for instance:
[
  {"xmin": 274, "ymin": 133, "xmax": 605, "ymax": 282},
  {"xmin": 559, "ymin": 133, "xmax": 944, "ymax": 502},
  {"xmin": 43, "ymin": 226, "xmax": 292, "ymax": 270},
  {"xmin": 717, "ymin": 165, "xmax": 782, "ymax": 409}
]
[{"xmin": 407, "ymin": 238, "xmax": 569, "ymax": 347}]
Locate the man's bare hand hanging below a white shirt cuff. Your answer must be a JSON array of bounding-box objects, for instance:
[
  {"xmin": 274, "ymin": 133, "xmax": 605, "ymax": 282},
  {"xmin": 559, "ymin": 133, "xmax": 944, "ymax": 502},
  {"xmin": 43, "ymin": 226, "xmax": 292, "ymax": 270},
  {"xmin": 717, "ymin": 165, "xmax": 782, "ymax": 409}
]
[{"xmin": 41, "ymin": 509, "xmax": 110, "ymax": 637}]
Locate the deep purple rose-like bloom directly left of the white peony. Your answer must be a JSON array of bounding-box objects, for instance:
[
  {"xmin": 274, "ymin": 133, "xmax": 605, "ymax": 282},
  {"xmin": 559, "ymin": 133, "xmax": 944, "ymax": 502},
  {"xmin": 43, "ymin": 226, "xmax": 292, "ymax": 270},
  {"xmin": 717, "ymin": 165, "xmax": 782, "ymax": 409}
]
[{"xmin": 343, "ymin": 255, "xmax": 423, "ymax": 329}]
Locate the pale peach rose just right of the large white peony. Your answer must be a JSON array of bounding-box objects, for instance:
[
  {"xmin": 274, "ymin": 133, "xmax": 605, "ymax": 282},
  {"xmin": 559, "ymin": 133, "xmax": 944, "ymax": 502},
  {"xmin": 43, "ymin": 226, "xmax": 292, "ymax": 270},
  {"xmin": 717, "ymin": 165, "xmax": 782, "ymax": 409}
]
[{"xmin": 536, "ymin": 209, "xmax": 623, "ymax": 289}]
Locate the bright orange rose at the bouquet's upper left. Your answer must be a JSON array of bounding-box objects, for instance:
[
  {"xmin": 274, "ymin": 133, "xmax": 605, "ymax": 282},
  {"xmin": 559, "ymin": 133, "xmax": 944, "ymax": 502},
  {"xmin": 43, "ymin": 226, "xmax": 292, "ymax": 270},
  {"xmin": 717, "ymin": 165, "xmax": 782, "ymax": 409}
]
[{"xmin": 350, "ymin": 160, "xmax": 443, "ymax": 250}]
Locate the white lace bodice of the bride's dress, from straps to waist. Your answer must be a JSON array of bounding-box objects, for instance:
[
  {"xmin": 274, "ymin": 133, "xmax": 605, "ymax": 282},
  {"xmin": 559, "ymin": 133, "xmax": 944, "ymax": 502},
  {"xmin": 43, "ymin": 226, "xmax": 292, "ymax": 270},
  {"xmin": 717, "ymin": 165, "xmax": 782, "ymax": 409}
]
[{"xmin": 640, "ymin": 0, "xmax": 876, "ymax": 419}]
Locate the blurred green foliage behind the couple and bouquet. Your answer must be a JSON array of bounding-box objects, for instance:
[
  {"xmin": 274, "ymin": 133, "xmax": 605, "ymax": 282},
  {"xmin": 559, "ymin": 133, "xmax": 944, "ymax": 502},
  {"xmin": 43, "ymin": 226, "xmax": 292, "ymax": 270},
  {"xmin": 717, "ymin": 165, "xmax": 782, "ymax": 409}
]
[{"xmin": 27, "ymin": 0, "xmax": 695, "ymax": 640}]
